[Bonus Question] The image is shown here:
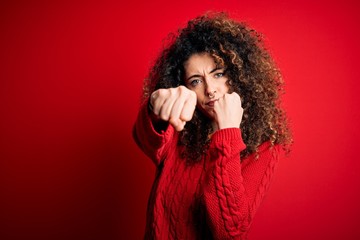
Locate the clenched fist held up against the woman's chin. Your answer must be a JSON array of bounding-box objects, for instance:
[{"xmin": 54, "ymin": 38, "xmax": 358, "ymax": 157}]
[{"xmin": 214, "ymin": 92, "xmax": 244, "ymax": 129}]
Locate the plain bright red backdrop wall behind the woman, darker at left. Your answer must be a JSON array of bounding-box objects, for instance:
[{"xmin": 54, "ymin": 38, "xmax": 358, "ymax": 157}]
[{"xmin": 0, "ymin": 0, "xmax": 360, "ymax": 240}]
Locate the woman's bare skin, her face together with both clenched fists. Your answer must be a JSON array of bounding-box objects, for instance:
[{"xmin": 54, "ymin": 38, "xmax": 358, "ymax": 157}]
[{"xmin": 150, "ymin": 53, "xmax": 243, "ymax": 131}]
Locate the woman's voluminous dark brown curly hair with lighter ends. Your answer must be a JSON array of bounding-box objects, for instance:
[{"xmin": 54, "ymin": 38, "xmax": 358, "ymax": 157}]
[{"xmin": 143, "ymin": 12, "xmax": 292, "ymax": 161}]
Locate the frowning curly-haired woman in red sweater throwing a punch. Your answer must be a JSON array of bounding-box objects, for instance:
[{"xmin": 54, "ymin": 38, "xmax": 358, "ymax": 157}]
[{"xmin": 133, "ymin": 13, "xmax": 291, "ymax": 239}]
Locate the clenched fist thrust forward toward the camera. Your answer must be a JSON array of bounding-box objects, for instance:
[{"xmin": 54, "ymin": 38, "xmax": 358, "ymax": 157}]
[{"xmin": 150, "ymin": 86, "xmax": 196, "ymax": 131}]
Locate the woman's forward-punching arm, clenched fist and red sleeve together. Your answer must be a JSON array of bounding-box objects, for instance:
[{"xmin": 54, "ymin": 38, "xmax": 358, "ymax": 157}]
[{"xmin": 133, "ymin": 86, "xmax": 196, "ymax": 165}]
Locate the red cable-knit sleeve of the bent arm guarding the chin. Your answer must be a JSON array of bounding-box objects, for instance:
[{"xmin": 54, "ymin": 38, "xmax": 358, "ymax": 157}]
[{"xmin": 204, "ymin": 128, "xmax": 278, "ymax": 239}]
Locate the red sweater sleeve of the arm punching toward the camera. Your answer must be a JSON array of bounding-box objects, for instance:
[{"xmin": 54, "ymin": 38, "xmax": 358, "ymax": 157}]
[{"xmin": 132, "ymin": 98, "xmax": 175, "ymax": 166}]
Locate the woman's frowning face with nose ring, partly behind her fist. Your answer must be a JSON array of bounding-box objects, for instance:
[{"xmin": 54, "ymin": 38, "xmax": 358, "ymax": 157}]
[{"xmin": 184, "ymin": 53, "xmax": 229, "ymax": 119}]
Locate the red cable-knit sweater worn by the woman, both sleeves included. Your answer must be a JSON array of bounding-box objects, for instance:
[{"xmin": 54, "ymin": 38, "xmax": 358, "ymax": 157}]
[{"xmin": 133, "ymin": 104, "xmax": 280, "ymax": 239}]
